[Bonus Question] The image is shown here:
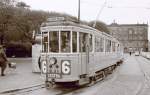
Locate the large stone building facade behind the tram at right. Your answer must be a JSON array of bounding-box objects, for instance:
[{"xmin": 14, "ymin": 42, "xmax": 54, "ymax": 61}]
[{"xmin": 108, "ymin": 23, "xmax": 148, "ymax": 52}]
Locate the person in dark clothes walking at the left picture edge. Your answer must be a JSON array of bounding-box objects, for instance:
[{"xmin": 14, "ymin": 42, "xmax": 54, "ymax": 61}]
[{"xmin": 0, "ymin": 45, "xmax": 8, "ymax": 76}]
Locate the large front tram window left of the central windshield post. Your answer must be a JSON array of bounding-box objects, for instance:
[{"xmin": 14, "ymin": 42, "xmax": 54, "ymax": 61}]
[{"xmin": 49, "ymin": 31, "xmax": 59, "ymax": 52}]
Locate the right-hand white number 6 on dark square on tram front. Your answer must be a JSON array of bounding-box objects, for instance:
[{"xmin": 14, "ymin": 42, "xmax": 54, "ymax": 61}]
[{"xmin": 62, "ymin": 61, "xmax": 71, "ymax": 74}]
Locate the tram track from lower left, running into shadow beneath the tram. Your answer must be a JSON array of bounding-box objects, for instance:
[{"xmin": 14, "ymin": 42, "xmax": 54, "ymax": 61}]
[{"xmin": 0, "ymin": 75, "xmax": 116, "ymax": 95}]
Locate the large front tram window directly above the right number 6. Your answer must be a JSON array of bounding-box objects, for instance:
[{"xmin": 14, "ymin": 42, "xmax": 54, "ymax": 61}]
[{"xmin": 61, "ymin": 31, "xmax": 71, "ymax": 52}]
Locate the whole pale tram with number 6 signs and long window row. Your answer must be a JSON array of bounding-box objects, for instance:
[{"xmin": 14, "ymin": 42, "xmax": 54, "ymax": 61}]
[{"xmin": 38, "ymin": 17, "xmax": 123, "ymax": 85}]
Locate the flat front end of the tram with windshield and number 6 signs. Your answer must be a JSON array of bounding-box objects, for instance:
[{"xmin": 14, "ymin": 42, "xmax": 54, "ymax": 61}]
[{"xmin": 40, "ymin": 27, "xmax": 80, "ymax": 86}]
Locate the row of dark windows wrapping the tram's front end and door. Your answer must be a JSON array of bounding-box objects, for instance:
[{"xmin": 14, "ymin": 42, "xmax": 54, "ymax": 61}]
[{"xmin": 42, "ymin": 31, "xmax": 93, "ymax": 53}]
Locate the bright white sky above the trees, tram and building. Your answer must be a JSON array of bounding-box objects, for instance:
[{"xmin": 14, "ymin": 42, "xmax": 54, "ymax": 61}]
[{"xmin": 20, "ymin": 0, "xmax": 150, "ymax": 40}]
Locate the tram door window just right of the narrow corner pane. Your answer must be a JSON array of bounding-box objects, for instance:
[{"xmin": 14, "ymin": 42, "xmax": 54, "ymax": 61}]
[{"xmin": 79, "ymin": 33, "xmax": 88, "ymax": 52}]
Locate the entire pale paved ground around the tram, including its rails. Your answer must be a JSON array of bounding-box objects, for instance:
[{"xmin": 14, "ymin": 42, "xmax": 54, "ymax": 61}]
[{"xmin": 0, "ymin": 55, "xmax": 150, "ymax": 95}]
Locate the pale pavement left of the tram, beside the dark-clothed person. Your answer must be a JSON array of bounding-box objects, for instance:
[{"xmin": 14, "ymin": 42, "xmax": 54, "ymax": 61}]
[{"xmin": 0, "ymin": 58, "xmax": 44, "ymax": 92}]
